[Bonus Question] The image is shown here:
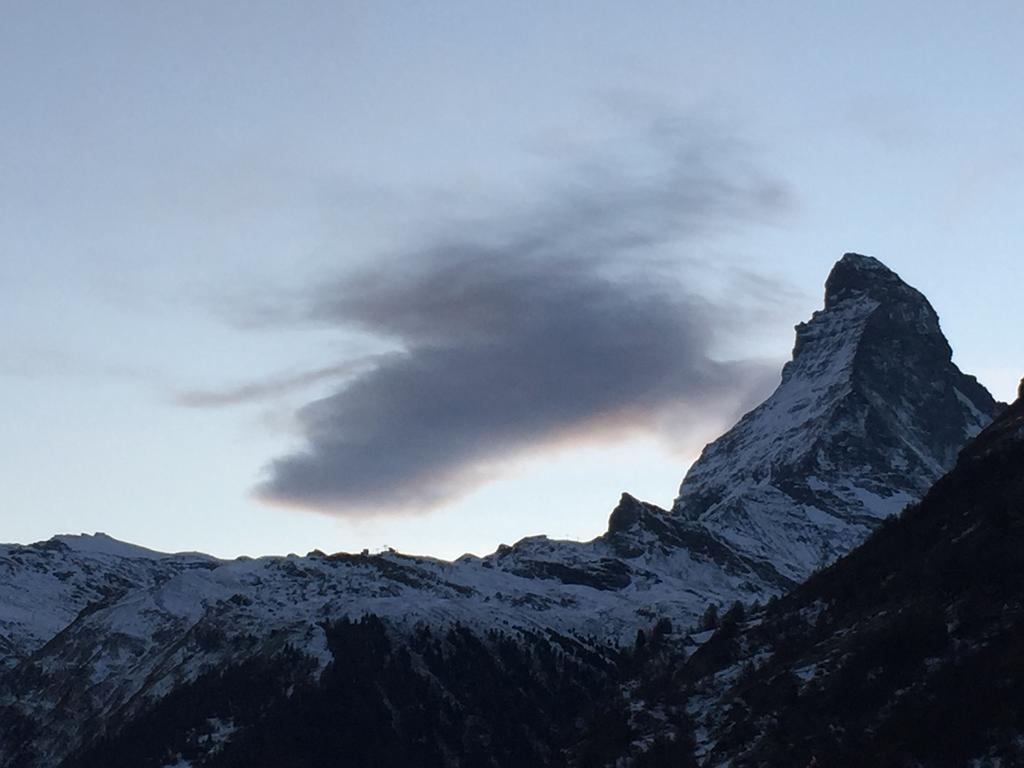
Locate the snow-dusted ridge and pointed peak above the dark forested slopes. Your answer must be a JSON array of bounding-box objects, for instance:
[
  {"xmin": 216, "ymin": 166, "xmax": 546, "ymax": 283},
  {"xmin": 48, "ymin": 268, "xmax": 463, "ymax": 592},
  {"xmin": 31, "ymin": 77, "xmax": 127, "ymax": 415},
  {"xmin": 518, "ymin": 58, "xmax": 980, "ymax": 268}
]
[{"xmin": 0, "ymin": 255, "xmax": 998, "ymax": 768}]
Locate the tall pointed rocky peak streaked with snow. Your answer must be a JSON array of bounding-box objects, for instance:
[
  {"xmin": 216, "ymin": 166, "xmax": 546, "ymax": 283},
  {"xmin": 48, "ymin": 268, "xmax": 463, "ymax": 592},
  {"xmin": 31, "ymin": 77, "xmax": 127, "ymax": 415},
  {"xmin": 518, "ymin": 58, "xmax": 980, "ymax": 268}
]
[{"xmin": 673, "ymin": 254, "xmax": 999, "ymax": 582}]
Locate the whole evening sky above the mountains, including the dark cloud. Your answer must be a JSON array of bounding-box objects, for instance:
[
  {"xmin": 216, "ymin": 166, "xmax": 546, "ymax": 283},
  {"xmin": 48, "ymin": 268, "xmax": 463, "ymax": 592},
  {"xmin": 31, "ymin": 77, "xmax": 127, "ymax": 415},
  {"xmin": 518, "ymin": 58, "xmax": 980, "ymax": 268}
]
[{"xmin": 0, "ymin": 0, "xmax": 1024, "ymax": 558}]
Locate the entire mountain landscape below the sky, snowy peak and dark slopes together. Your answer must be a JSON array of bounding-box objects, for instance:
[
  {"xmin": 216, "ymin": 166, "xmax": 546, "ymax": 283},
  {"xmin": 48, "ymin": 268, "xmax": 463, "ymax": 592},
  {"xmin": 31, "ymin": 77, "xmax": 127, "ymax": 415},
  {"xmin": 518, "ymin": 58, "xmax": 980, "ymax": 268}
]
[{"xmin": 0, "ymin": 254, "xmax": 1007, "ymax": 768}]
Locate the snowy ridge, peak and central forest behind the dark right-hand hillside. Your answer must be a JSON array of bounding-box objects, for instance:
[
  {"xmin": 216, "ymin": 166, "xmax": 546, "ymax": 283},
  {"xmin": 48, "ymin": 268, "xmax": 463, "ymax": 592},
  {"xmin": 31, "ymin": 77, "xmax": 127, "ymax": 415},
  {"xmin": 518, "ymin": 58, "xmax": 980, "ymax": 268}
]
[{"xmin": 0, "ymin": 254, "xmax": 1003, "ymax": 768}]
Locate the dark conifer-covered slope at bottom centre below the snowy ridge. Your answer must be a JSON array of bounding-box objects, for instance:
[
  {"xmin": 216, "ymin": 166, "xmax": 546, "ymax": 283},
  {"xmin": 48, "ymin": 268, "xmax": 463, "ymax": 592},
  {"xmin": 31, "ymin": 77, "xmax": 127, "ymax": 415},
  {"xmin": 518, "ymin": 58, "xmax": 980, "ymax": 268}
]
[{"xmin": 63, "ymin": 615, "xmax": 623, "ymax": 768}]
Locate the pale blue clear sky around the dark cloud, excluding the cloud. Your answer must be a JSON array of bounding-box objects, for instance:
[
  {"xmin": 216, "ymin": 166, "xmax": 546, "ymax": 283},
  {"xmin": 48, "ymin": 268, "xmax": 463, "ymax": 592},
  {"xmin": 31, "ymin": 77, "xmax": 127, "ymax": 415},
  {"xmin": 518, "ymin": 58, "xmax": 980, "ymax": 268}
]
[{"xmin": 0, "ymin": 2, "xmax": 1024, "ymax": 556}]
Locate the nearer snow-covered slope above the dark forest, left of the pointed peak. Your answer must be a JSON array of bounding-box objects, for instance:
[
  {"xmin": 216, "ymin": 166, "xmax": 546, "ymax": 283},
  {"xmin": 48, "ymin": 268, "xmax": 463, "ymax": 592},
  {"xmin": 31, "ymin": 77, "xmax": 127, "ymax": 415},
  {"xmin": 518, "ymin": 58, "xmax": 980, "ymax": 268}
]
[{"xmin": 0, "ymin": 539, "xmax": 761, "ymax": 765}]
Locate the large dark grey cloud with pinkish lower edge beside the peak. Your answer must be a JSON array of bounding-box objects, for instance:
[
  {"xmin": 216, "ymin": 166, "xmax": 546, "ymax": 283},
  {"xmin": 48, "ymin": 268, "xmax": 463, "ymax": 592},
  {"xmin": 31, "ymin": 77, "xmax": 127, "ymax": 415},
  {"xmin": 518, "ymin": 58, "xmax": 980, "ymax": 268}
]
[{"xmin": 251, "ymin": 126, "xmax": 784, "ymax": 514}]
